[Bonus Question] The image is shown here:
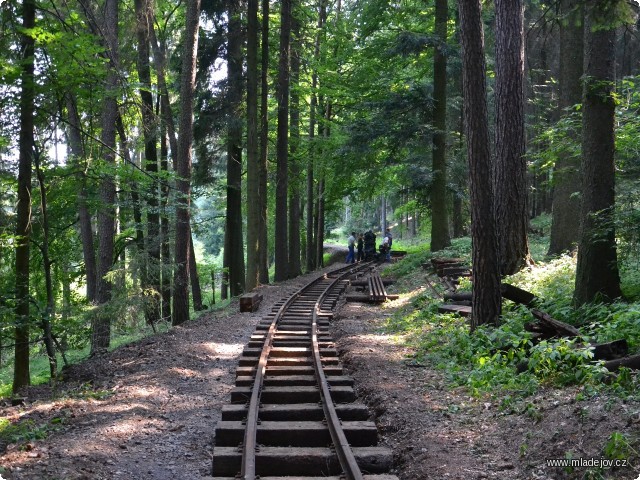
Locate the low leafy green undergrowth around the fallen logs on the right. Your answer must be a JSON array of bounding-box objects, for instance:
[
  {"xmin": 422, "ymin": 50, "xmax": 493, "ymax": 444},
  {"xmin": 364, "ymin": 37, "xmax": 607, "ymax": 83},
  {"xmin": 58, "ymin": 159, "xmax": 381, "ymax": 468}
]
[{"xmin": 385, "ymin": 244, "xmax": 640, "ymax": 404}]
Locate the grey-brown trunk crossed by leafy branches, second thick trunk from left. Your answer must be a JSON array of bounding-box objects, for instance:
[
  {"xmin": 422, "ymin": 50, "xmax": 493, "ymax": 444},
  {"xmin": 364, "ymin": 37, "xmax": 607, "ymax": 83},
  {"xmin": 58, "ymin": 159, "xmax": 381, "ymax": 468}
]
[{"xmin": 91, "ymin": 0, "xmax": 120, "ymax": 355}]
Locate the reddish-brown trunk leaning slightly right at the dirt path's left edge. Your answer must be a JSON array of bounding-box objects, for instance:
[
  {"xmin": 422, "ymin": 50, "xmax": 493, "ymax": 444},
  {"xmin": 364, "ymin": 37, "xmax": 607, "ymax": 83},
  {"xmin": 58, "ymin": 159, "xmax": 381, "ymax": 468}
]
[{"xmin": 172, "ymin": 0, "xmax": 200, "ymax": 325}]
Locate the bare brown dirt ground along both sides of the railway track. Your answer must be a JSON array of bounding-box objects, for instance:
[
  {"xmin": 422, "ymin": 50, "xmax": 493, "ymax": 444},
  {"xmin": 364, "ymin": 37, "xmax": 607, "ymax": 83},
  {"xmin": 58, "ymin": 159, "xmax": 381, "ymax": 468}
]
[{"xmin": 0, "ymin": 249, "xmax": 640, "ymax": 480}]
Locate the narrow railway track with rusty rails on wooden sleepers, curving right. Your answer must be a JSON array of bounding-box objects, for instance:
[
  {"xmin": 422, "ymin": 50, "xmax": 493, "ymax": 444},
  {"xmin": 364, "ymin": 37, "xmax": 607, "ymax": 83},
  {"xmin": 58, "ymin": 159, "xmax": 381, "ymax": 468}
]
[{"xmin": 212, "ymin": 263, "xmax": 397, "ymax": 480}]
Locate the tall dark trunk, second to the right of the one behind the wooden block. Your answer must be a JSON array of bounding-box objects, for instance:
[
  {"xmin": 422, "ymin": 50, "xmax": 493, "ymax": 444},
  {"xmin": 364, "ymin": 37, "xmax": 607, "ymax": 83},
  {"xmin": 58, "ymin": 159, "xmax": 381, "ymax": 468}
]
[{"xmin": 274, "ymin": 0, "xmax": 291, "ymax": 282}]
